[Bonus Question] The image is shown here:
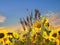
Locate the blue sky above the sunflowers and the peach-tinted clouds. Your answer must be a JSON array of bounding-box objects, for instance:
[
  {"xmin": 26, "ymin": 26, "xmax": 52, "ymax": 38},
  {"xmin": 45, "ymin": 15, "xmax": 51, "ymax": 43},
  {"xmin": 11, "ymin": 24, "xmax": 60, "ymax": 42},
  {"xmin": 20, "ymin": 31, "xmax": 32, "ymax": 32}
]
[{"xmin": 0, "ymin": 0, "xmax": 60, "ymax": 26}]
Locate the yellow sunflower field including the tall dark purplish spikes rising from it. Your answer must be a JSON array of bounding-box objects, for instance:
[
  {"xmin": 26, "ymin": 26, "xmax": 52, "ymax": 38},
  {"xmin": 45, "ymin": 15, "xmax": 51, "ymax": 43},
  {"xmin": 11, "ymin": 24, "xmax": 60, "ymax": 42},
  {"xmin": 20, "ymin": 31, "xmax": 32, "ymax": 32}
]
[{"xmin": 0, "ymin": 10, "xmax": 60, "ymax": 45}]
